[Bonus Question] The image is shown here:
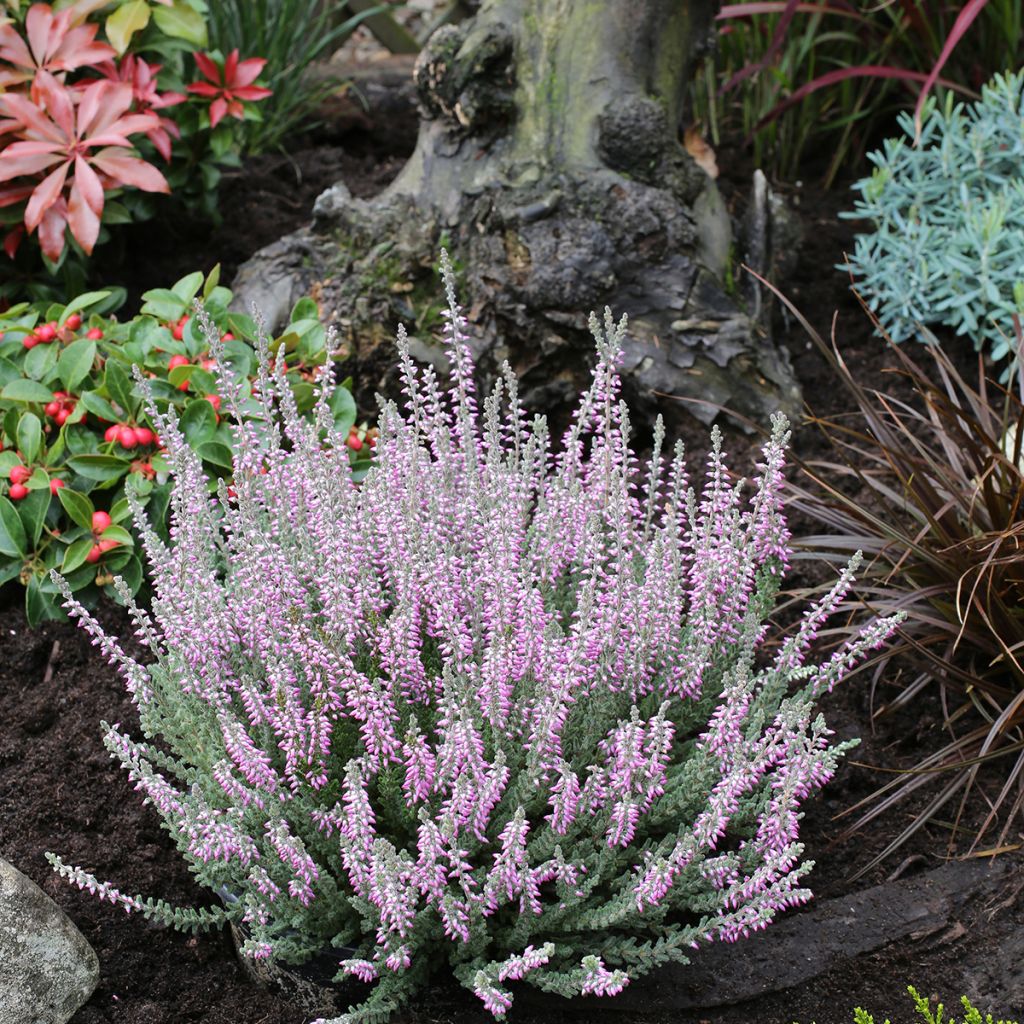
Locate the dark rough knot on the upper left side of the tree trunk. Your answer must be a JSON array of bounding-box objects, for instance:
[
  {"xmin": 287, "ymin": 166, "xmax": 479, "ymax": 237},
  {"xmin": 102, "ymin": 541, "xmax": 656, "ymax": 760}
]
[{"xmin": 413, "ymin": 25, "xmax": 515, "ymax": 135}]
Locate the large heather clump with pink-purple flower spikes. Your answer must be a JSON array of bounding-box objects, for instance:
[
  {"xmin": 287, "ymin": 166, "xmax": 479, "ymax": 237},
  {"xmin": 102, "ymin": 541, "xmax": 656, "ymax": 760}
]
[{"xmin": 50, "ymin": 258, "xmax": 894, "ymax": 1022}]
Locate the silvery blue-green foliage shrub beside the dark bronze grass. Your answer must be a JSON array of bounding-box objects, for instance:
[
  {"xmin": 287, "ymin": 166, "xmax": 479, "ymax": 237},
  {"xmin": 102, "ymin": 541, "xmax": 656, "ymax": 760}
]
[{"xmin": 841, "ymin": 72, "xmax": 1024, "ymax": 379}]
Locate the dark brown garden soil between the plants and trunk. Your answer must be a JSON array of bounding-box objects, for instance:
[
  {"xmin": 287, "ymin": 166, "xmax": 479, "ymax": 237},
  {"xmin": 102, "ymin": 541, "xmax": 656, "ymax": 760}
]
[{"xmin": 0, "ymin": 61, "xmax": 1024, "ymax": 1024}]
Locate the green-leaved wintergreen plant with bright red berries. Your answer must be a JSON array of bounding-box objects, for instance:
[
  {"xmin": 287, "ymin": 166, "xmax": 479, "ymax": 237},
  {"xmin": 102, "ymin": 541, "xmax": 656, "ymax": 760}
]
[{"xmin": 0, "ymin": 269, "xmax": 373, "ymax": 625}]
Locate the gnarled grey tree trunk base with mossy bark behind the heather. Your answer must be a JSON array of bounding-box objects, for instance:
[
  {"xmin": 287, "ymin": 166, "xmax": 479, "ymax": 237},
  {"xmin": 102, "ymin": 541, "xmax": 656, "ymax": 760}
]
[{"xmin": 237, "ymin": 0, "xmax": 800, "ymax": 432}]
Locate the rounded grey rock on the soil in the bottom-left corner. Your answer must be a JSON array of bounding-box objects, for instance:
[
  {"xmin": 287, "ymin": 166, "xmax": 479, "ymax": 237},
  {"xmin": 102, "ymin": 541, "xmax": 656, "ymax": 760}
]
[{"xmin": 0, "ymin": 859, "xmax": 99, "ymax": 1024}]
